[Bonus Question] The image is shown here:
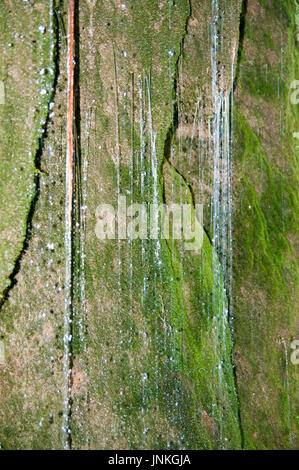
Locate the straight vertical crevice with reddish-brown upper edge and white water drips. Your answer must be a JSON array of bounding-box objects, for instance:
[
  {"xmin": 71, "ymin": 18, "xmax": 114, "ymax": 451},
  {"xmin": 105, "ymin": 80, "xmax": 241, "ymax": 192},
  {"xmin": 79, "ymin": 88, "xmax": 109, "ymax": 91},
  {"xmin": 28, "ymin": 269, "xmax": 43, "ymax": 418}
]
[{"xmin": 63, "ymin": 0, "xmax": 85, "ymax": 449}]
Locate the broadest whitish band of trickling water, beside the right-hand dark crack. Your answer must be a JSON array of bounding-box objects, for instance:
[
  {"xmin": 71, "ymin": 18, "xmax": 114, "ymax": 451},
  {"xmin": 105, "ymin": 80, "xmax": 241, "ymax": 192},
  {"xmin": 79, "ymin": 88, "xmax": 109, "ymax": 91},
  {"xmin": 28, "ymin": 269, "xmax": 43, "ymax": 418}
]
[{"xmin": 211, "ymin": 0, "xmax": 234, "ymax": 446}]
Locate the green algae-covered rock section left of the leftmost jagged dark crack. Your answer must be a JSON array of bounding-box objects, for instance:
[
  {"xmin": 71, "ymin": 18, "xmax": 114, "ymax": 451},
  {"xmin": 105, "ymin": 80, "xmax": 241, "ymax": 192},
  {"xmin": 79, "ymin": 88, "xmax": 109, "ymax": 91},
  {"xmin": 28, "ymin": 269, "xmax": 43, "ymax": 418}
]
[{"xmin": 0, "ymin": 1, "xmax": 56, "ymax": 302}]
